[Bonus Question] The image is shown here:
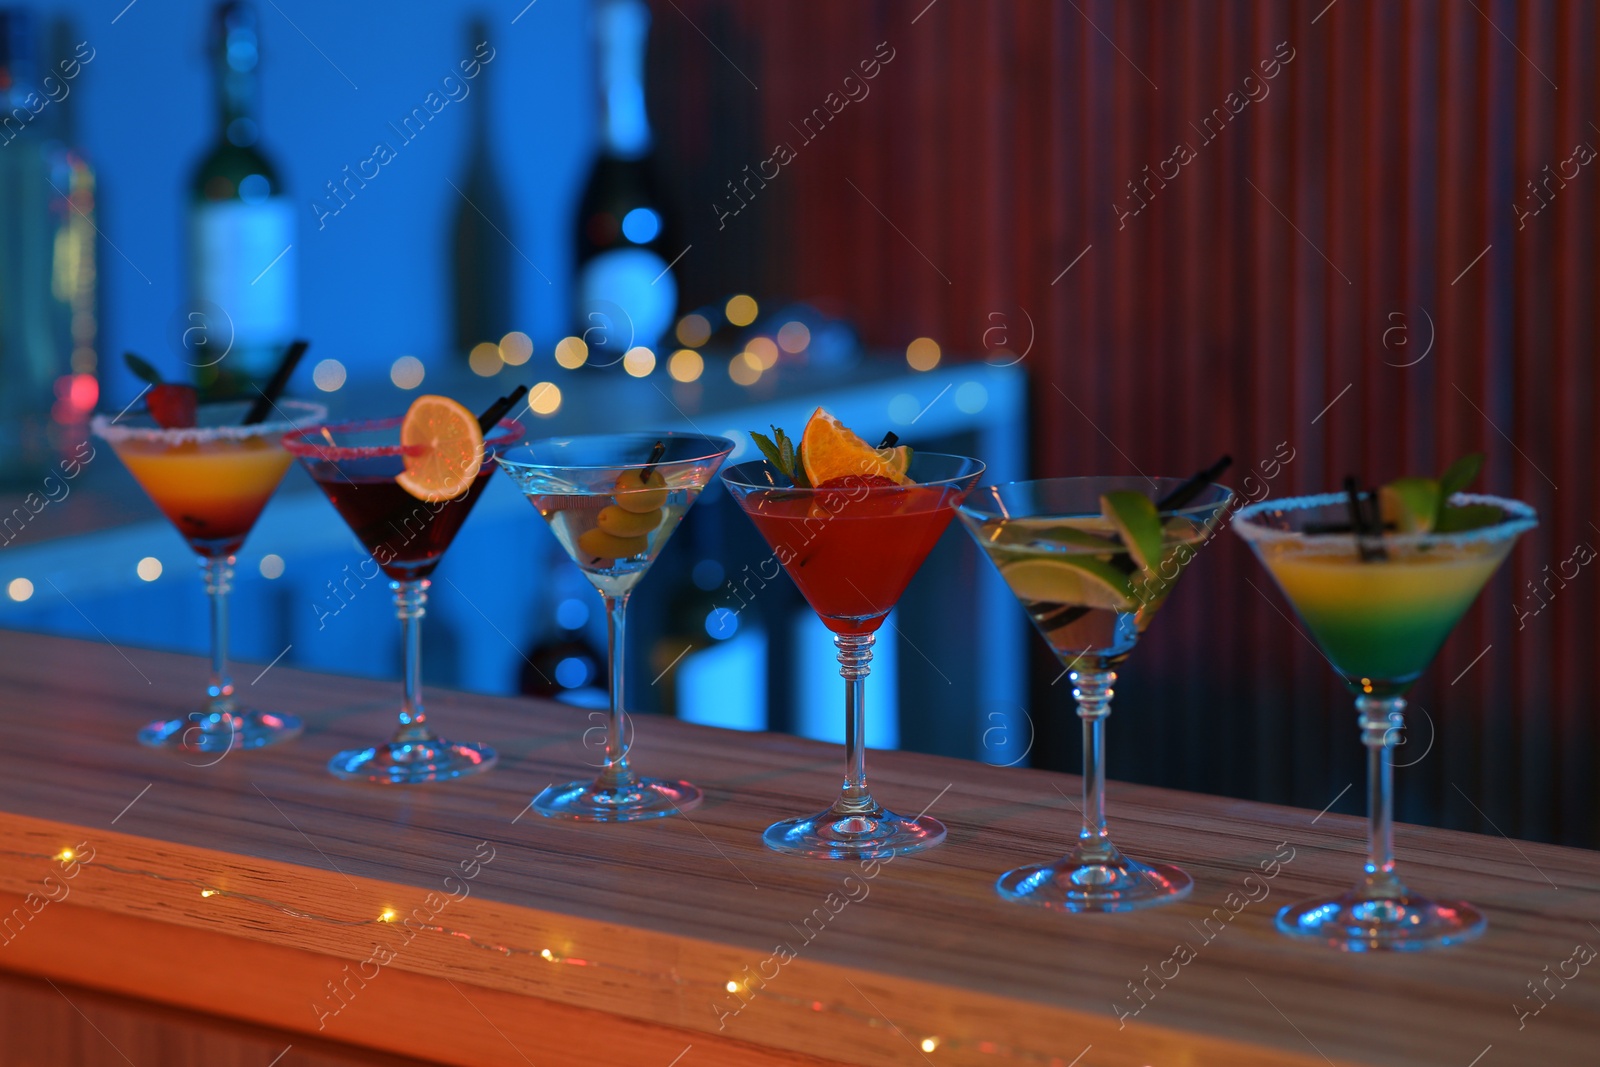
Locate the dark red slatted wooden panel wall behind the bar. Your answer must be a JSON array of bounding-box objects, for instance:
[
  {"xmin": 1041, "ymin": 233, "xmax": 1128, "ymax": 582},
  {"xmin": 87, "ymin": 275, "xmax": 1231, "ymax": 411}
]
[{"xmin": 653, "ymin": 0, "xmax": 1600, "ymax": 844}]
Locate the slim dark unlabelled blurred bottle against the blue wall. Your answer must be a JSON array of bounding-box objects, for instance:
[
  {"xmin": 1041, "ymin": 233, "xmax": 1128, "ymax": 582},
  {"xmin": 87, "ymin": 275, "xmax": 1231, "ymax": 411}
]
[{"xmin": 454, "ymin": 21, "xmax": 514, "ymax": 355}]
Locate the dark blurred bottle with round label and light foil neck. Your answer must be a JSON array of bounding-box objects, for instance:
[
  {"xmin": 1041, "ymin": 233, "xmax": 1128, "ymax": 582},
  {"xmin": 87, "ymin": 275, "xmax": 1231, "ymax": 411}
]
[{"xmin": 574, "ymin": 0, "xmax": 683, "ymax": 366}]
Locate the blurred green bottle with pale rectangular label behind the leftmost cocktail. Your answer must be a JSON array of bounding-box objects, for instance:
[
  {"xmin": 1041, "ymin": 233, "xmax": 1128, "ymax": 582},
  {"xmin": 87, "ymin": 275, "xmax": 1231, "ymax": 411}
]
[{"xmin": 181, "ymin": 2, "xmax": 299, "ymax": 397}]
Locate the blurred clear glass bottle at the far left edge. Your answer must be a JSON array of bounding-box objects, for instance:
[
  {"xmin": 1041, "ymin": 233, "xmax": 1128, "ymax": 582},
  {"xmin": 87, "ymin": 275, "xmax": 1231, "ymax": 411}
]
[{"xmin": 0, "ymin": 8, "xmax": 99, "ymax": 480}]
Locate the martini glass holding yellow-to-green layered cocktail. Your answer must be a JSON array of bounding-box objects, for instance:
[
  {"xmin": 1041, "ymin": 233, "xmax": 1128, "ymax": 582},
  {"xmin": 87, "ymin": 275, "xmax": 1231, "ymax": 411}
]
[{"xmin": 1234, "ymin": 493, "xmax": 1538, "ymax": 952}]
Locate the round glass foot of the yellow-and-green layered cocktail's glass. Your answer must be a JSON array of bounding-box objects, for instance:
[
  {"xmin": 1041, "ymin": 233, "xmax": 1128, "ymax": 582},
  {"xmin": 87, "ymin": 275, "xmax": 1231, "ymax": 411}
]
[{"xmin": 1278, "ymin": 893, "xmax": 1486, "ymax": 952}]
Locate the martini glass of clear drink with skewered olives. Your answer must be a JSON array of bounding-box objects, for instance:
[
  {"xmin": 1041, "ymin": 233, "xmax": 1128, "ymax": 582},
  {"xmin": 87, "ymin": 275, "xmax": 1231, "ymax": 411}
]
[{"xmin": 499, "ymin": 432, "xmax": 733, "ymax": 822}]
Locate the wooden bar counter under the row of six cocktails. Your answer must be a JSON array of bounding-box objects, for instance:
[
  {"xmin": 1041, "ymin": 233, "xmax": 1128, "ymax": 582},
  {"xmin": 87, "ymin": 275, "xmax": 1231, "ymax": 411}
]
[{"xmin": 0, "ymin": 632, "xmax": 1600, "ymax": 1067}]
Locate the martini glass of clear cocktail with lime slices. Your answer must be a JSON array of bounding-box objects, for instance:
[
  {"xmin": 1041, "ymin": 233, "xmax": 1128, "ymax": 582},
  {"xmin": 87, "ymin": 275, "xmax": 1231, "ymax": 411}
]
[{"xmin": 962, "ymin": 478, "xmax": 1234, "ymax": 912}]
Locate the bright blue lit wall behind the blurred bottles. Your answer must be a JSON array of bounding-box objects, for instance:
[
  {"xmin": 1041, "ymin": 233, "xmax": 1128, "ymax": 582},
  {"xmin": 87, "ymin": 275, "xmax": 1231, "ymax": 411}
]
[{"xmin": 38, "ymin": 0, "xmax": 595, "ymax": 405}]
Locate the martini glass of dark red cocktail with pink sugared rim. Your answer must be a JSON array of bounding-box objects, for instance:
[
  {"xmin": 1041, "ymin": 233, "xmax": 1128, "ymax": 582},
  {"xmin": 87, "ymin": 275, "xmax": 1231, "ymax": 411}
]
[{"xmin": 283, "ymin": 416, "xmax": 522, "ymax": 785}]
